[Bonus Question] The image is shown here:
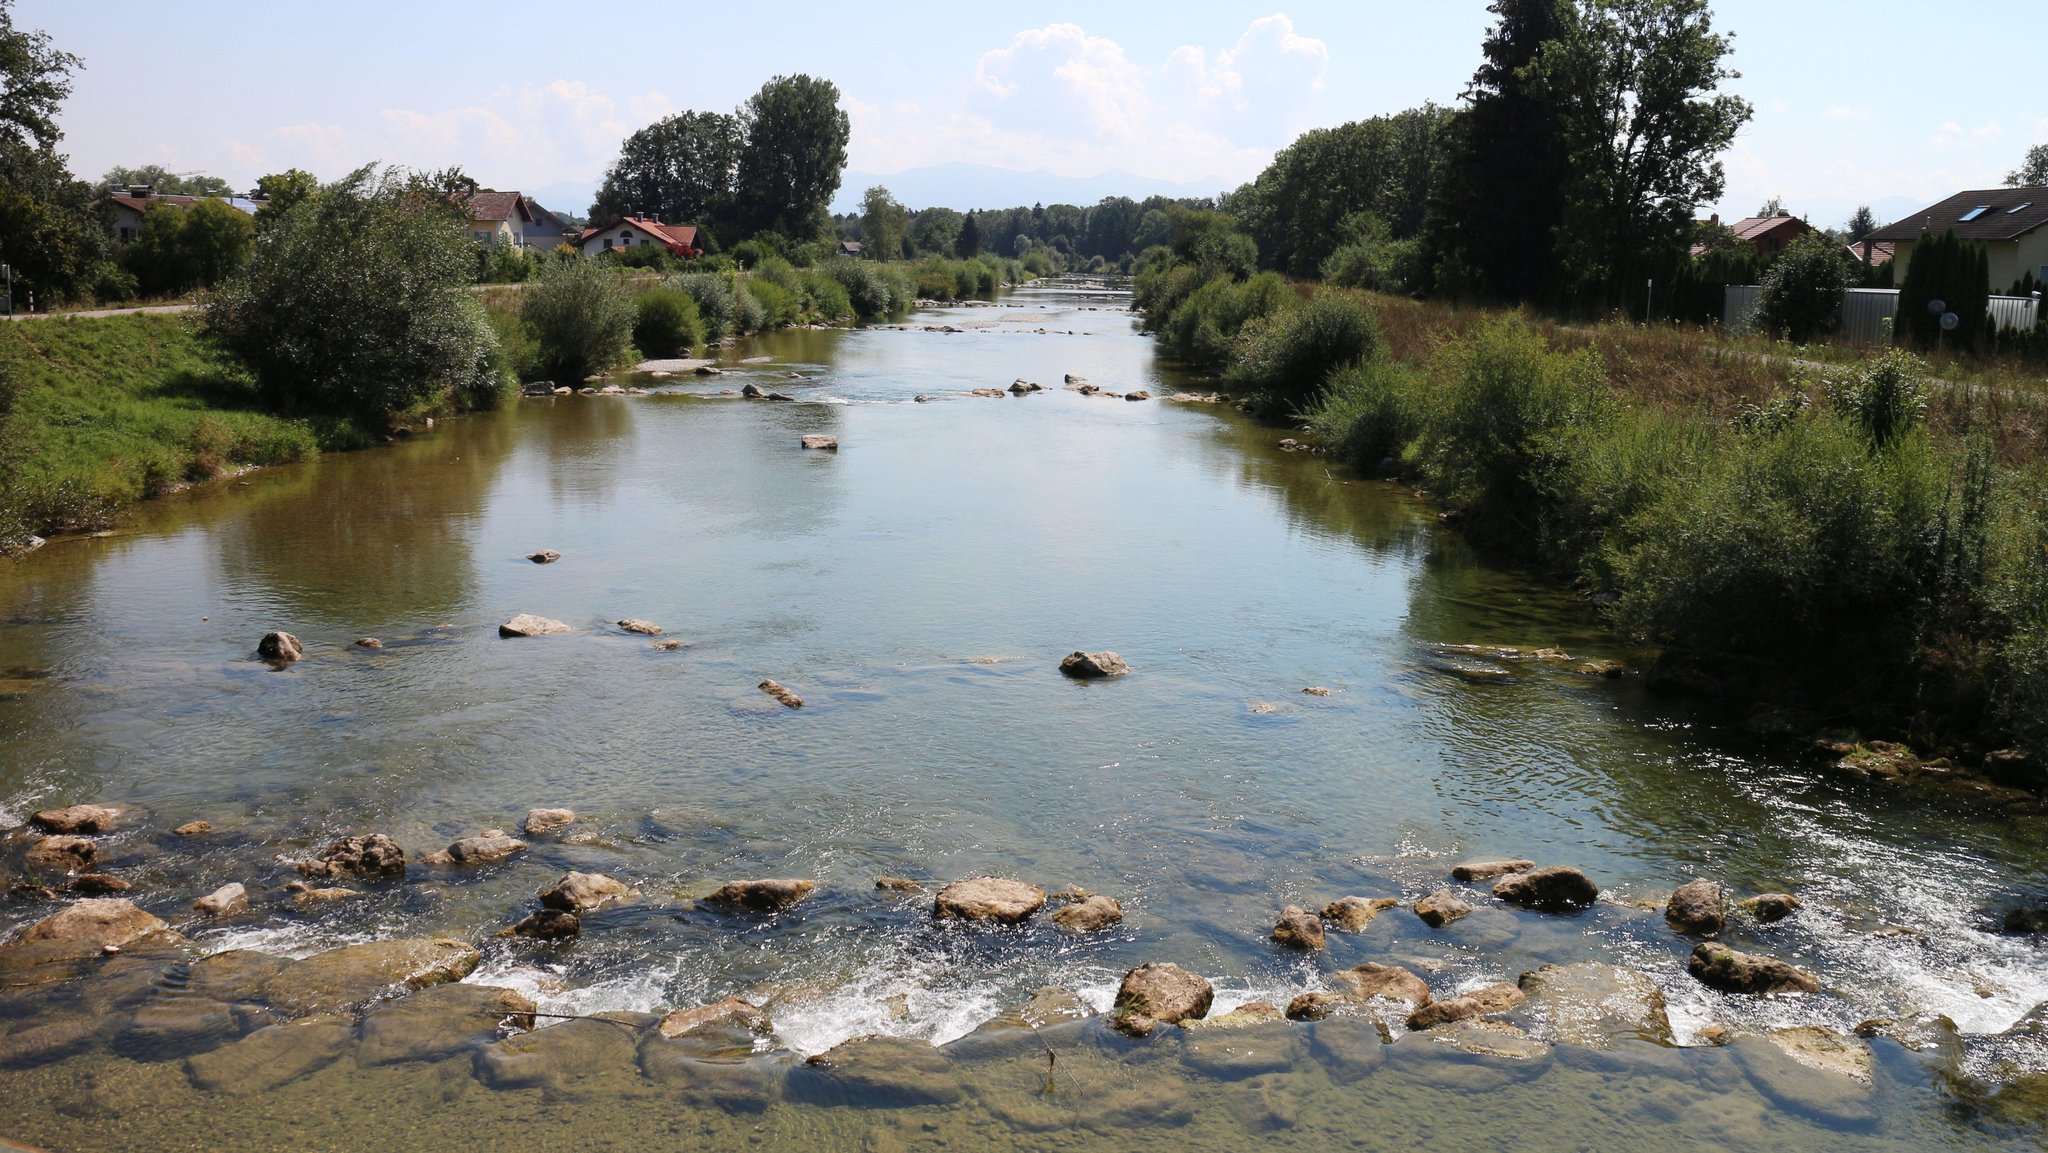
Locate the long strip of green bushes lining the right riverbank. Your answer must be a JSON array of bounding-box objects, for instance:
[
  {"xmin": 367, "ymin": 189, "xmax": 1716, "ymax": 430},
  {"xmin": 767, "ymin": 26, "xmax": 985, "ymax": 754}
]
[{"xmin": 1139, "ymin": 276, "xmax": 2048, "ymax": 788}]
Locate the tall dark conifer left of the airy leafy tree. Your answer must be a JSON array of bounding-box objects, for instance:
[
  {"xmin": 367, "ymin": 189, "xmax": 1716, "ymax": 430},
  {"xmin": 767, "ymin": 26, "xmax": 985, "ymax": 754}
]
[{"xmin": 1425, "ymin": 0, "xmax": 1571, "ymax": 301}]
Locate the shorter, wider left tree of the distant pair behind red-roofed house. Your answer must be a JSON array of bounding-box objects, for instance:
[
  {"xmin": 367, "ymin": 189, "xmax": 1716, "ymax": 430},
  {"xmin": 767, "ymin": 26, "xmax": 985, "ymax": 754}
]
[{"xmin": 592, "ymin": 113, "xmax": 741, "ymax": 231}]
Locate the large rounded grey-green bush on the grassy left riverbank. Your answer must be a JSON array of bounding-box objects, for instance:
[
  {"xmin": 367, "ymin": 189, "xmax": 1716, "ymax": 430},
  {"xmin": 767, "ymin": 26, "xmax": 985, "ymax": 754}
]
[{"xmin": 205, "ymin": 159, "xmax": 508, "ymax": 420}]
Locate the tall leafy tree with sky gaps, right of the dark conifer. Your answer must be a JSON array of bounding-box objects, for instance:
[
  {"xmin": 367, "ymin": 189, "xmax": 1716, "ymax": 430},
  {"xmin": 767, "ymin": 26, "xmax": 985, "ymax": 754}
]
[{"xmin": 1534, "ymin": 0, "xmax": 1753, "ymax": 287}]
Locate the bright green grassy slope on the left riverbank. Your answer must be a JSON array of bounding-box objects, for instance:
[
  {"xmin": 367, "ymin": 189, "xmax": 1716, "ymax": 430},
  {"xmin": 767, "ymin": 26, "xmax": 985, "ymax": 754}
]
[{"xmin": 0, "ymin": 315, "xmax": 319, "ymax": 532}]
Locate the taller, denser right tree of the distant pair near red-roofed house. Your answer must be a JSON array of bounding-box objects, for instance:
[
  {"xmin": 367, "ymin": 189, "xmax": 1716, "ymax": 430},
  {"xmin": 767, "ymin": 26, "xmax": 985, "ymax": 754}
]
[{"xmin": 737, "ymin": 74, "xmax": 852, "ymax": 240}]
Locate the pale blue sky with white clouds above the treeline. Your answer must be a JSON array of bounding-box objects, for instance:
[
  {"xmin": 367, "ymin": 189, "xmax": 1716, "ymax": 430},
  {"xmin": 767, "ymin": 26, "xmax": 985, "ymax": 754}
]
[{"xmin": 14, "ymin": 0, "xmax": 2048, "ymax": 225}]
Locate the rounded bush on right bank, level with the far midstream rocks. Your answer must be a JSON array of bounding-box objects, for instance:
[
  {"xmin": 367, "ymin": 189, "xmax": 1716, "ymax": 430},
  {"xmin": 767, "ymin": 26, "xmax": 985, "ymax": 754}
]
[{"xmin": 1223, "ymin": 289, "xmax": 1382, "ymax": 412}]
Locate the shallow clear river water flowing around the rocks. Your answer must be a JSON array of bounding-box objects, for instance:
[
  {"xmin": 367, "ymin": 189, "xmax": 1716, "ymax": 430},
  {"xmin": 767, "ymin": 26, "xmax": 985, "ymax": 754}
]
[{"xmin": 0, "ymin": 285, "xmax": 2048, "ymax": 1151}]
